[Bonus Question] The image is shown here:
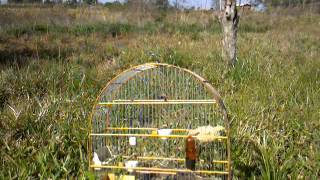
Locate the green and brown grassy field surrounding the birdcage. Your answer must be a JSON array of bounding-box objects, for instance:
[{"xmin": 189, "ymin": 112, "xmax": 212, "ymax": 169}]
[{"xmin": 0, "ymin": 6, "xmax": 320, "ymax": 179}]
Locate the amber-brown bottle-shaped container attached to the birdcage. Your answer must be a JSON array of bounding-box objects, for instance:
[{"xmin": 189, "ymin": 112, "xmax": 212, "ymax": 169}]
[{"xmin": 186, "ymin": 136, "xmax": 197, "ymax": 170}]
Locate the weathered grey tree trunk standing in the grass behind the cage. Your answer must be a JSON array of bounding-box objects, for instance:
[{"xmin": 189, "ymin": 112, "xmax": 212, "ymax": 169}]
[{"xmin": 220, "ymin": 0, "xmax": 239, "ymax": 65}]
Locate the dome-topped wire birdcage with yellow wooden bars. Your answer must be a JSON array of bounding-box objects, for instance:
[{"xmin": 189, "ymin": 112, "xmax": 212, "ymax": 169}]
[{"xmin": 88, "ymin": 63, "xmax": 231, "ymax": 179}]
